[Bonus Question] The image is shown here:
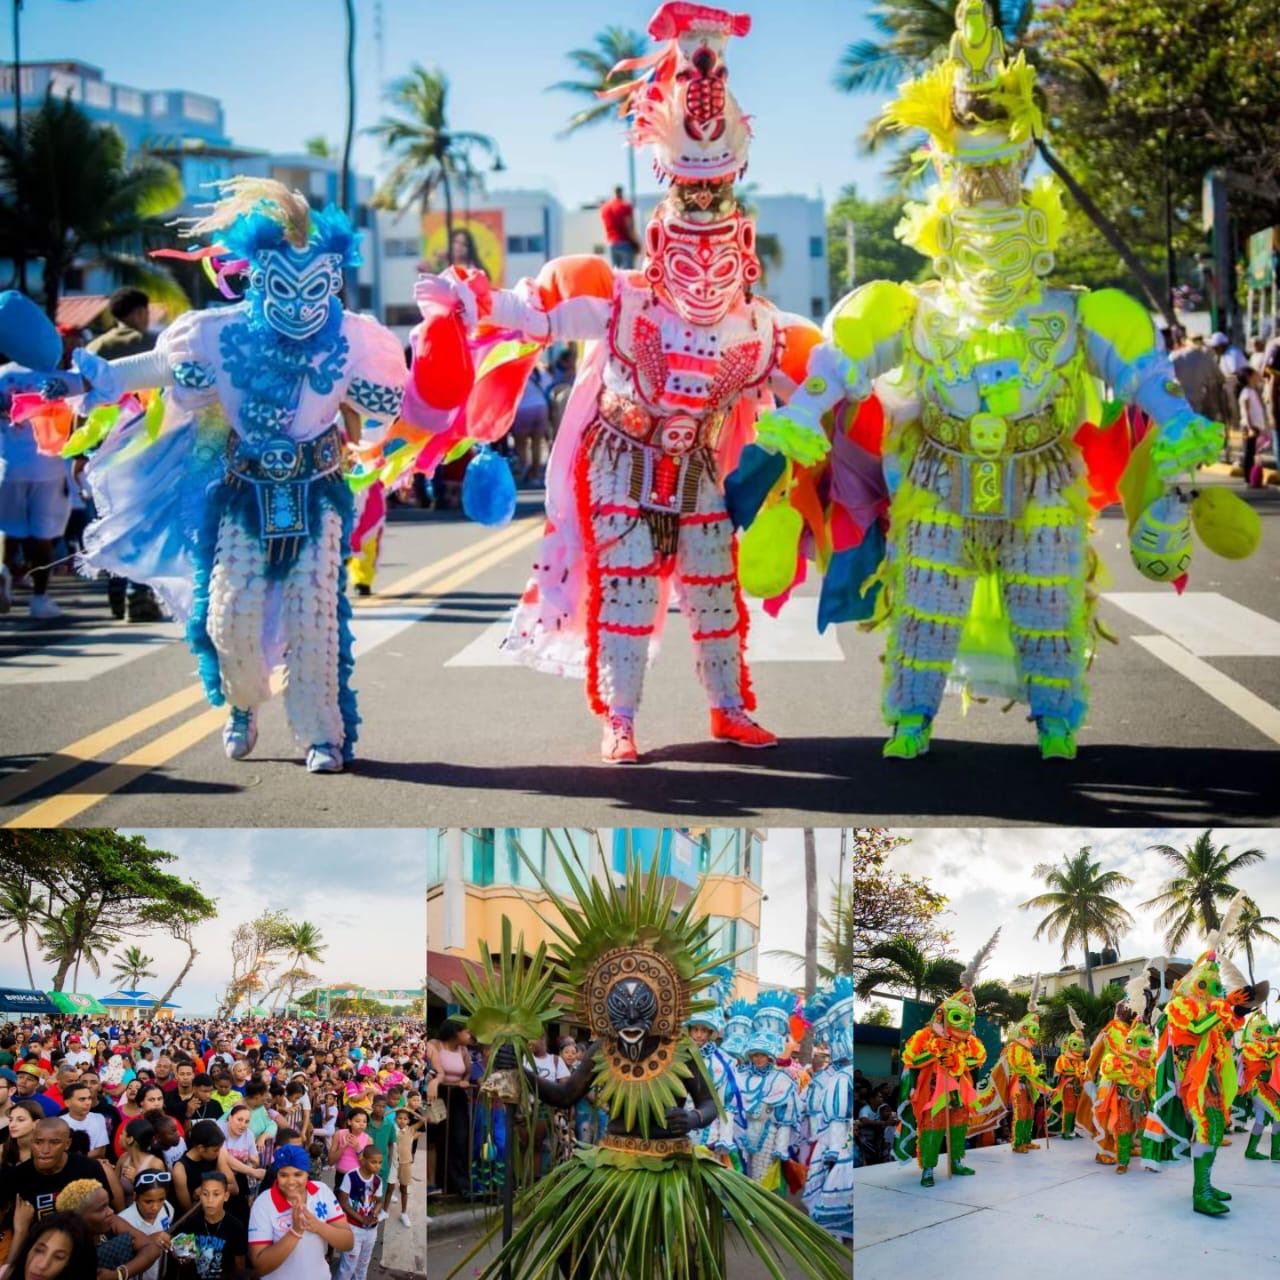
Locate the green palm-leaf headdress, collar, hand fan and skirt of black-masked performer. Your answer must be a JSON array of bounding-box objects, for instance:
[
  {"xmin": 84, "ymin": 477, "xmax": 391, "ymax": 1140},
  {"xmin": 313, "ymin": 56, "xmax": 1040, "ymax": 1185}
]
[{"xmin": 440, "ymin": 838, "xmax": 852, "ymax": 1280}]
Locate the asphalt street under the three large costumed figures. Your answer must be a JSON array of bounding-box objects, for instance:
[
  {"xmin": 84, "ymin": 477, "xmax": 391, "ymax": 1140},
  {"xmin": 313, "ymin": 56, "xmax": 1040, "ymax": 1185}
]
[{"xmin": 0, "ymin": 483, "xmax": 1280, "ymax": 827}]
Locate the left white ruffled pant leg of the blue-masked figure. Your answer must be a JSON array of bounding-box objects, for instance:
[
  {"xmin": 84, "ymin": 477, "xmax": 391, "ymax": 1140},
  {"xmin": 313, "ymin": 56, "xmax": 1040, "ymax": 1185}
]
[{"xmin": 207, "ymin": 516, "xmax": 271, "ymax": 710}]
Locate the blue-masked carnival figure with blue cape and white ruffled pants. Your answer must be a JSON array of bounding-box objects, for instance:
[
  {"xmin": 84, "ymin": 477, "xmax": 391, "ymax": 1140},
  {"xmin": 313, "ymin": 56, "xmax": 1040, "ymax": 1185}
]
[{"xmin": 77, "ymin": 178, "xmax": 407, "ymax": 773}]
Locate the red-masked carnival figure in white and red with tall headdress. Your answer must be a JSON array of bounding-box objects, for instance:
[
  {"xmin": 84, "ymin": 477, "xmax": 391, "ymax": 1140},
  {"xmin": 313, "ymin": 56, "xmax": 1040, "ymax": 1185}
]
[{"xmin": 420, "ymin": 4, "xmax": 818, "ymax": 763}]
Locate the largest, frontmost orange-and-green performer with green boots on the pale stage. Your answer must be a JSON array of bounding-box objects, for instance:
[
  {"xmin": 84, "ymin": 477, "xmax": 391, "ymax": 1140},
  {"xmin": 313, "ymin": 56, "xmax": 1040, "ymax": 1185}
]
[{"xmin": 1147, "ymin": 895, "xmax": 1266, "ymax": 1217}]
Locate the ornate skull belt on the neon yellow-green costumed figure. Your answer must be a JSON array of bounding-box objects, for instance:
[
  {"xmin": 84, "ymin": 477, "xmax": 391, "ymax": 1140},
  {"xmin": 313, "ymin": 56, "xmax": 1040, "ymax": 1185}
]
[{"xmin": 910, "ymin": 403, "xmax": 1076, "ymax": 520}]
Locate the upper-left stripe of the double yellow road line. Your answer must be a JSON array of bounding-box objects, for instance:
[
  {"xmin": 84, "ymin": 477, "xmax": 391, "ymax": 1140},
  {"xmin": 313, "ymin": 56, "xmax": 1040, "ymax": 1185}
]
[{"xmin": 0, "ymin": 516, "xmax": 543, "ymax": 805}]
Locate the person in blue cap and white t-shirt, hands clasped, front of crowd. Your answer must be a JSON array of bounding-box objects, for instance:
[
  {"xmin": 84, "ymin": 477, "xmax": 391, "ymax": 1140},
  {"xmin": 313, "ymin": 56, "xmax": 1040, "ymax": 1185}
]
[{"xmin": 248, "ymin": 1146, "xmax": 356, "ymax": 1280}]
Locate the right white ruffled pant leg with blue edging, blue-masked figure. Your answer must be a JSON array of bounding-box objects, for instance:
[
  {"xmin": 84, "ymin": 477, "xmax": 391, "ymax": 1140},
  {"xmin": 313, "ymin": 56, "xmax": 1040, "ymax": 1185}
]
[{"xmin": 280, "ymin": 511, "xmax": 346, "ymax": 748}]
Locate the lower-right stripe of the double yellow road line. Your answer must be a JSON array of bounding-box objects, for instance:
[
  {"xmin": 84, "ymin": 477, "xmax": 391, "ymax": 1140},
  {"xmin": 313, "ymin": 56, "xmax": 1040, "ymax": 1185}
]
[{"xmin": 4, "ymin": 521, "xmax": 541, "ymax": 827}]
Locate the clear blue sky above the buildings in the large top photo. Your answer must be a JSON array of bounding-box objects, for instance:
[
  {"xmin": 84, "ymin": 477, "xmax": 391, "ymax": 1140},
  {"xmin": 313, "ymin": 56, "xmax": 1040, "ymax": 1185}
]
[{"xmin": 12, "ymin": 0, "xmax": 883, "ymax": 206}]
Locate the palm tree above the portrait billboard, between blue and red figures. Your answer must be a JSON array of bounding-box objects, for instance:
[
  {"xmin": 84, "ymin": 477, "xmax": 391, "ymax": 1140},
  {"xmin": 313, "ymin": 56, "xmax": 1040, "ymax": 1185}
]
[{"xmin": 369, "ymin": 64, "xmax": 498, "ymax": 242}]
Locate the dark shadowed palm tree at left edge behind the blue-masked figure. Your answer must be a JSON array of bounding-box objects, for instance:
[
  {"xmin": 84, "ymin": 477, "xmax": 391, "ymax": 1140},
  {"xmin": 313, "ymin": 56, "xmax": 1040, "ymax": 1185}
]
[{"xmin": 0, "ymin": 95, "xmax": 187, "ymax": 317}]
